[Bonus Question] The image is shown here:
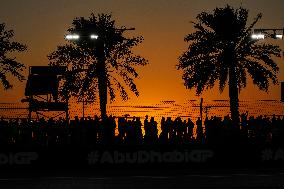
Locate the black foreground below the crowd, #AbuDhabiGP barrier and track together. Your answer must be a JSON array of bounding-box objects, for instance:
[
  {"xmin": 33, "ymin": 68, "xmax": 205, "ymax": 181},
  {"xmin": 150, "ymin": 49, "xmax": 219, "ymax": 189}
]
[{"xmin": 0, "ymin": 145, "xmax": 284, "ymax": 189}]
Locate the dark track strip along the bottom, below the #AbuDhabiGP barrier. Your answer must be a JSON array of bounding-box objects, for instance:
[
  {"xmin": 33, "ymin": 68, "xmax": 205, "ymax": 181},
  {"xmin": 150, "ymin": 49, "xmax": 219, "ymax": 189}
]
[{"xmin": 0, "ymin": 170, "xmax": 284, "ymax": 189}]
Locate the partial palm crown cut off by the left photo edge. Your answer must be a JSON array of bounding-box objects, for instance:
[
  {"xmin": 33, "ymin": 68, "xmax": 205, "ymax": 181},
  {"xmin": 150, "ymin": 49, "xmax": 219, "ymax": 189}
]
[{"xmin": 0, "ymin": 23, "xmax": 27, "ymax": 89}]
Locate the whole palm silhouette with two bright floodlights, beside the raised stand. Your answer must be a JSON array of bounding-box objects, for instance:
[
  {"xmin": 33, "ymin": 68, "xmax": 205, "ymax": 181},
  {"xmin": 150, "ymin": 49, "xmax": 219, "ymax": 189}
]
[{"xmin": 48, "ymin": 14, "xmax": 148, "ymax": 118}]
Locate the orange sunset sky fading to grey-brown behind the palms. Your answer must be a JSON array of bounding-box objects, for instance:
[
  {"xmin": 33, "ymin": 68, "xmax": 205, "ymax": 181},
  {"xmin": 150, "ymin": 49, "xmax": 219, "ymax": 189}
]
[{"xmin": 0, "ymin": 0, "xmax": 284, "ymax": 104}]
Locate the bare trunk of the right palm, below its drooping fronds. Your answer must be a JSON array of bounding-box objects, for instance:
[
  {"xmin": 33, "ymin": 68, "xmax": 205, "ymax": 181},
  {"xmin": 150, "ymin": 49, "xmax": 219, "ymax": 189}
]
[{"xmin": 229, "ymin": 66, "xmax": 239, "ymax": 128}]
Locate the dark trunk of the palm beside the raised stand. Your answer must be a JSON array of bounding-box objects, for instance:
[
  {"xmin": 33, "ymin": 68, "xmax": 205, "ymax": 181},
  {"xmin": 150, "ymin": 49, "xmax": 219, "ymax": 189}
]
[{"xmin": 98, "ymin": 42, "xmax": 107, "ymax": 120}]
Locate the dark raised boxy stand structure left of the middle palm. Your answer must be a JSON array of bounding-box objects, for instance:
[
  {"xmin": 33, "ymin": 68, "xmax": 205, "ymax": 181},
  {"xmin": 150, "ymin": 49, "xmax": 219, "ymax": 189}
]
[{"xmin": 22, "ymin": 66, "xmax": 69, "ymax": 120}]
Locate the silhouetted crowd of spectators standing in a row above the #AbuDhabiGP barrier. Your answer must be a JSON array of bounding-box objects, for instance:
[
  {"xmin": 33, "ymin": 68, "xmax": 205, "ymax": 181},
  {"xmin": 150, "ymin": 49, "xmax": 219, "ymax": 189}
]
[{"xmin": 0, "ymin": 113, "xmax": 284, "ymax": 148}]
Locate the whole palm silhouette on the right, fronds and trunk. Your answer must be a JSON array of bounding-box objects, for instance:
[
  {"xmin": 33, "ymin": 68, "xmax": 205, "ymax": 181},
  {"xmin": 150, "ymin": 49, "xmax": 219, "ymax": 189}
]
[{"xmin": 177, "ymin": 5, "xmax": 281, "ymax": 126}]
